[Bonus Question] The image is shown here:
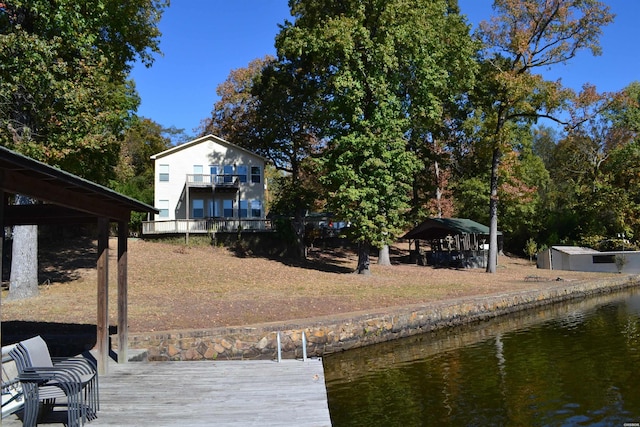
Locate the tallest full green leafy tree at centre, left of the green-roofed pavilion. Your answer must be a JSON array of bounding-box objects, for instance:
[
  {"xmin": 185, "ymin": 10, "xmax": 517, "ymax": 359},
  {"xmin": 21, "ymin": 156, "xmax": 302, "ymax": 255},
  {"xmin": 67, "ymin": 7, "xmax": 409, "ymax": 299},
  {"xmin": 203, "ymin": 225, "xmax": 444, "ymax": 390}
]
[{"xmin": 276, "ymin": 0, "xmax": 478, "ymax": 274}]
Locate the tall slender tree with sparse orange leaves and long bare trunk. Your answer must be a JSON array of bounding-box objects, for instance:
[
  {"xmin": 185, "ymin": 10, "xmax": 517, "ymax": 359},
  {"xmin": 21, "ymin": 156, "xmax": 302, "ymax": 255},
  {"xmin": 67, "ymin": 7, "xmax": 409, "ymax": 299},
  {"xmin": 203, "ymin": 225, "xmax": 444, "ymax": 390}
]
[{"xmin": 470, "ymin": 0, "xmax": 613, "ymax": 273}]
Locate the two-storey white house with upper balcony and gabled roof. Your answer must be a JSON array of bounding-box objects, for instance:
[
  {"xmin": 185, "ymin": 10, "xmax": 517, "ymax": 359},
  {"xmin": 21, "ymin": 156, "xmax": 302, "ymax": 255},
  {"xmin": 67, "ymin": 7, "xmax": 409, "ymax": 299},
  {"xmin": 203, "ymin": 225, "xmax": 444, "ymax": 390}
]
[{"xmin": 143, "ymin": 135, "xmax": 267, "ymax": 234}]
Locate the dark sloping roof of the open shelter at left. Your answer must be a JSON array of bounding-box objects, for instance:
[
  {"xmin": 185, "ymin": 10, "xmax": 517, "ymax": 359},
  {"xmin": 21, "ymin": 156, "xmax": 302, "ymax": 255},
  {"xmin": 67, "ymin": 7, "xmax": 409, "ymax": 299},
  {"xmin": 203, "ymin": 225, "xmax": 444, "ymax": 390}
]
[{"xmin": 0, "ymin": 146, "xmax": 158, "ymax": 226}]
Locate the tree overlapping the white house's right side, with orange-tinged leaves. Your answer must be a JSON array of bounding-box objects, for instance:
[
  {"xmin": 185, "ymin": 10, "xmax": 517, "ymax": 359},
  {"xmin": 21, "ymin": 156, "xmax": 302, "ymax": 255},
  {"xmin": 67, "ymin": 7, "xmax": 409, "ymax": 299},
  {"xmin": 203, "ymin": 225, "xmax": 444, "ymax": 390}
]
[{"xmin": 203, "ymin": 56, "xmax": 322, "ymax": 258}]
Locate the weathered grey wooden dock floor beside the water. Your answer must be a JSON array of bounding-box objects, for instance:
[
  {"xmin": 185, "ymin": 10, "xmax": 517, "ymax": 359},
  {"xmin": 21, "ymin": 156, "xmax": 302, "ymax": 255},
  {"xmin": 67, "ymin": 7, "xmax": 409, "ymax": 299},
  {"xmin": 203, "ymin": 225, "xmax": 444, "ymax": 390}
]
[{"xmin": 2, "ymin": 359, "xmax": 331, "ymax": 427}]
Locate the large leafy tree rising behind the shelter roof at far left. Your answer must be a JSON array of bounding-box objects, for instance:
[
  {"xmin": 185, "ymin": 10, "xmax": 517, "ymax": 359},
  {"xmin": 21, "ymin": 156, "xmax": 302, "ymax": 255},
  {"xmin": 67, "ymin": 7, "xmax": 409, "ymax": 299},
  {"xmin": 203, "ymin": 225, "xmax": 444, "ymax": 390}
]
[{"xmin": 0, "ymin": 0, "xmax": 167, "ymax": 297}]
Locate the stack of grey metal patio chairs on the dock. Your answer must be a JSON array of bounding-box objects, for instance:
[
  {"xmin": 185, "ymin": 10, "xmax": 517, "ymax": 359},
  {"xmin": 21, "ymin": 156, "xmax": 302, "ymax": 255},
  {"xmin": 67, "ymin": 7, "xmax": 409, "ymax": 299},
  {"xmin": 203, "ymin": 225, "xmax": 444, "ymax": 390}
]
[{"xmin": 10, "ymin": 336, "xmax": 99, "ymax": 427}]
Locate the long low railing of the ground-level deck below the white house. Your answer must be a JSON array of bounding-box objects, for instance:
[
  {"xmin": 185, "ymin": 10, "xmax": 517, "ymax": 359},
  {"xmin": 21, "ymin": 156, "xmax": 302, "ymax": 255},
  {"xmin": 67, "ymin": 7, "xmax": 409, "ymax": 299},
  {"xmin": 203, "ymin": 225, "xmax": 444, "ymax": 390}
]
[{"xmin": 142, "ymin": 218, "xmax": 273, "ymax": 234}]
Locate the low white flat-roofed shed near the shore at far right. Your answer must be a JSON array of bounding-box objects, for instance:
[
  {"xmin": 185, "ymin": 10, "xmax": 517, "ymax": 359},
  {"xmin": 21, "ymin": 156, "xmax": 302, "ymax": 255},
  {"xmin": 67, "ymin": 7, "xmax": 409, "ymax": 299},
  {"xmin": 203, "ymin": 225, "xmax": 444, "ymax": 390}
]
[{"xmin": 537, "ymin": 246, "xmax": 640, "ymax": 274}]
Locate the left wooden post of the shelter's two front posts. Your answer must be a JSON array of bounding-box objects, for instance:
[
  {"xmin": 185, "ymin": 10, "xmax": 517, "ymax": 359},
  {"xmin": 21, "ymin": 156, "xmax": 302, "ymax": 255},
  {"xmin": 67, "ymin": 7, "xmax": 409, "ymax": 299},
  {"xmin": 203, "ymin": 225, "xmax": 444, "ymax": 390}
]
[{"xmin": 96, "ymin": 217, "xmax": 110, "ymax": 375}]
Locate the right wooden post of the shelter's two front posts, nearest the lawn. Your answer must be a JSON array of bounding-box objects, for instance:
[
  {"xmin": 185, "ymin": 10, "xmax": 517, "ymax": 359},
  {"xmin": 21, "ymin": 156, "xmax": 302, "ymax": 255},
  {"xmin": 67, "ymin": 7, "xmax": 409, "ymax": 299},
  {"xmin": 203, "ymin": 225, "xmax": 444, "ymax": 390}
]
[{"xmin": 118, "ymin": 221, "xmax": 129, "ymax": 363}]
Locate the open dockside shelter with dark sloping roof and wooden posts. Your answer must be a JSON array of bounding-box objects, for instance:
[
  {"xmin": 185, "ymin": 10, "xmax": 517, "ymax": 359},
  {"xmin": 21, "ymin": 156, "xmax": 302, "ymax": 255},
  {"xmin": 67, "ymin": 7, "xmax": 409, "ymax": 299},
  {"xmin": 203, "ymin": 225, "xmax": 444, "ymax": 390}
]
[{"xmin": 0, "ymin": 146, "xmax": 158, "ymax": 374}]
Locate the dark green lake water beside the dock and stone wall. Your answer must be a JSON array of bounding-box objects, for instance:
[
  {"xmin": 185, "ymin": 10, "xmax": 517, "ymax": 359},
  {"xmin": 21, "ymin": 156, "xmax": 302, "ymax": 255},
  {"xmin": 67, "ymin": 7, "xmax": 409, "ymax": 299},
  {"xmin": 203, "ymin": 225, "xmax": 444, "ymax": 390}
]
[{"xmin": 324, "ymin": 289, "xmax": 640, "ymax": 427}]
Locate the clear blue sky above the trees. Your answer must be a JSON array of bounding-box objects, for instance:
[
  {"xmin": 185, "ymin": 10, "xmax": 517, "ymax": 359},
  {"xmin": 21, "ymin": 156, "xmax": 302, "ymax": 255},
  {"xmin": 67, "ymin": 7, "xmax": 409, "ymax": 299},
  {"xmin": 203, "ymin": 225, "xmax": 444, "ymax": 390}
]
[{"xmin": 132, "ymin": 0, "xmax": 640, "ymax": 139}]
